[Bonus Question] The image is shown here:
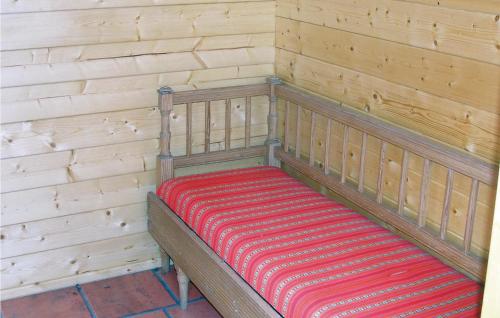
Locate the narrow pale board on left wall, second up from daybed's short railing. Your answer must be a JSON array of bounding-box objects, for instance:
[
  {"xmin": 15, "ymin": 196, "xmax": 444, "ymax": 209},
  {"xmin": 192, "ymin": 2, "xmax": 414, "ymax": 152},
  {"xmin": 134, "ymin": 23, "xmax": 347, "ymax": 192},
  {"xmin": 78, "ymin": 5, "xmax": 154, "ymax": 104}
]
[{"xmin": 2, "ymin": 47, "xmax": 274, "ymax": 87}]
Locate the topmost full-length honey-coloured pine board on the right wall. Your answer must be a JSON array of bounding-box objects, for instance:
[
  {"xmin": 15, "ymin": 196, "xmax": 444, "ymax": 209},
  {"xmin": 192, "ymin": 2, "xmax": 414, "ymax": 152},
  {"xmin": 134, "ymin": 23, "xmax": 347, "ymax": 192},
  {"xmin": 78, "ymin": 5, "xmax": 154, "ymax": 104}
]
[{"xmin": 276, "ymin": 0, "xmax": 500, "ymax": 64}]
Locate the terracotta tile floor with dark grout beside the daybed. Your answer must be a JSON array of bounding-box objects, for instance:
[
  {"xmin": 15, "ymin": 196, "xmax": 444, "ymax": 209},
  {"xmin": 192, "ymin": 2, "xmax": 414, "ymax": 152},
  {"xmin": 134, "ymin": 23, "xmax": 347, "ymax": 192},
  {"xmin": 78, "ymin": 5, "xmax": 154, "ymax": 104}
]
[{"xmin": 0, "ymin": 269, "xmax": 220, "ymax": 318}]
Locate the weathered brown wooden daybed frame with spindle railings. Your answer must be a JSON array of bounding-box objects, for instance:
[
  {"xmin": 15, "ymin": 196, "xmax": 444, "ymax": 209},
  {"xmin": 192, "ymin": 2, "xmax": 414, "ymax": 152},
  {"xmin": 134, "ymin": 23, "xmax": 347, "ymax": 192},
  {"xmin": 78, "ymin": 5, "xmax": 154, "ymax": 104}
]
[{"xmin": 148, "ymin": 77, "xmax": 498, "ymax": 318}]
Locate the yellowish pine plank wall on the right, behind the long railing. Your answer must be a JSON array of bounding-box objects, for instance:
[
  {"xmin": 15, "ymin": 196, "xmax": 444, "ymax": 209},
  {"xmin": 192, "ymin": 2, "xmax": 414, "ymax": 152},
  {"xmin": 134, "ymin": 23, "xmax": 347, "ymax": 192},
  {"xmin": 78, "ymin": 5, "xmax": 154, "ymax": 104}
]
[{"xmin": 276, "ymin": 0, "xmax": 500, "ymax": 254}]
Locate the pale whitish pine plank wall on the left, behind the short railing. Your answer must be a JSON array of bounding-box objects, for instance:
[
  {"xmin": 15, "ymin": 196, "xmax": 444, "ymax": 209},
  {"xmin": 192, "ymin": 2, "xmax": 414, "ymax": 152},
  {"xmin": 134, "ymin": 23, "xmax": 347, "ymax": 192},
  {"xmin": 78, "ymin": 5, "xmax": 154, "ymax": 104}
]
[{"xmin": 1, "ymin": 0, "xmax": 275, "ymax": 298}]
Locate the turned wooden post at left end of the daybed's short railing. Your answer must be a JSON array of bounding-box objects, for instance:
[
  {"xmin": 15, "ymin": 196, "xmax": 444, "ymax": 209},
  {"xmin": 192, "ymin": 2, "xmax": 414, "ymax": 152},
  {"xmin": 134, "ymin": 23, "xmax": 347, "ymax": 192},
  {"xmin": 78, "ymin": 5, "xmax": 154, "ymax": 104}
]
[{"xmin": 158, "ymin": 87, "xmax": 174, "ymax": 185}]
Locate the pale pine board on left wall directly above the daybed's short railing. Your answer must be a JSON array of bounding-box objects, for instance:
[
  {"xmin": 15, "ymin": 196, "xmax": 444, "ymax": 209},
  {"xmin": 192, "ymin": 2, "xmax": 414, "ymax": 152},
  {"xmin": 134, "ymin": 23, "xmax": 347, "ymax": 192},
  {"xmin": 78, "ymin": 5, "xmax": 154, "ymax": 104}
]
[{"xmin": 1, "ymin": 64, "xmax": 274, "ymax": 123}]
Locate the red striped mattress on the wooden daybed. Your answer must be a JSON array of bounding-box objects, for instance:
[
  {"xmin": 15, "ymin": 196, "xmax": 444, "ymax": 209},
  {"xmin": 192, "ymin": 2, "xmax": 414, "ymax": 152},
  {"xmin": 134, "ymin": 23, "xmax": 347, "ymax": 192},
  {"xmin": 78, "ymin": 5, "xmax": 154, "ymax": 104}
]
[{"xmin": 157, "ymin": 167, "xmax": 482, "ymax": 317}]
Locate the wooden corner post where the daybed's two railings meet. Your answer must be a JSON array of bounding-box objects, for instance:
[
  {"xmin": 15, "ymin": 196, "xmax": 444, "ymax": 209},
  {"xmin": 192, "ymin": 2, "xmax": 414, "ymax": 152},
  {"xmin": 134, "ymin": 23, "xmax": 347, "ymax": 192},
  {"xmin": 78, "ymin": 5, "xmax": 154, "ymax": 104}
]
[{"xmin": 265, "ymin": 76, "xmax": 282, "ymax": 167}]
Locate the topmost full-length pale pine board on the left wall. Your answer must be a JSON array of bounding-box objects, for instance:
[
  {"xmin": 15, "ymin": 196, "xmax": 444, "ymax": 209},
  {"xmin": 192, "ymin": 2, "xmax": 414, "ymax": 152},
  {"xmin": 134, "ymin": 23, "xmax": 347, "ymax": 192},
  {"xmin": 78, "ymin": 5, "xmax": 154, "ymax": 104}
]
[{"xmin": 2, "ymin": 1, "xmax": 274, "ymax": 50}]
